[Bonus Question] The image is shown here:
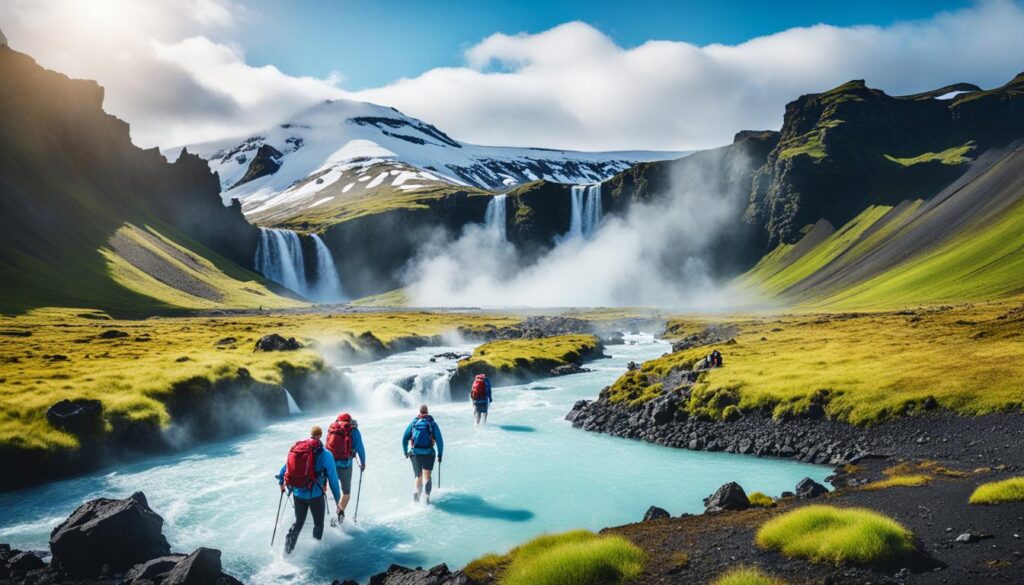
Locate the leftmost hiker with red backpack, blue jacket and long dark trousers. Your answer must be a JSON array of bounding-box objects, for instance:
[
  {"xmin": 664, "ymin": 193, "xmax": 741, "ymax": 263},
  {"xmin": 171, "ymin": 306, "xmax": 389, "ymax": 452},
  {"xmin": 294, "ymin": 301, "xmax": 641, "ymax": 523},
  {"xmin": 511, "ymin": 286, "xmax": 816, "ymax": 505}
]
[{"xmin": 278, "ymin": 426, "xmax": 341, "ymax": 554}]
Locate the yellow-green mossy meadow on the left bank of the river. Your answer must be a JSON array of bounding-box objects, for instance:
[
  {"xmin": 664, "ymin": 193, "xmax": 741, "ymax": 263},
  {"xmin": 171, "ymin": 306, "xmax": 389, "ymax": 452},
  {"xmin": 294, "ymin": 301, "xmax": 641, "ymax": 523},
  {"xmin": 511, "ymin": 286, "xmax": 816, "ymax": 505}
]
[{"xmin": 0, "ymin": 309, "xmax": 515, "ymax": 449}]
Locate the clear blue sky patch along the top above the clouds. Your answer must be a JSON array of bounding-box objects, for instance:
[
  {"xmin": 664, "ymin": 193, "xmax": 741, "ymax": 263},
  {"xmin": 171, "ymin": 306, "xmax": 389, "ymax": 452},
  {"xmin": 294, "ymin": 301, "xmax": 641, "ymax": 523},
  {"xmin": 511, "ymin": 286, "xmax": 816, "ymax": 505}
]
[{"xmin": 238, "ymin": 0, "xmax": 971, "ymax": 90}]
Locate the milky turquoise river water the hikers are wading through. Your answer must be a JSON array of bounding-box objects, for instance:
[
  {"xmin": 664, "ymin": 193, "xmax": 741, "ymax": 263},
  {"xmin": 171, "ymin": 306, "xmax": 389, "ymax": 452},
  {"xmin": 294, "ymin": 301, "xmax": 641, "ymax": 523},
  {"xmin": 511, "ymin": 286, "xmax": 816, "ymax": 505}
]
[{"xmin": 0, "ymin": 335, "xmax": 829, "ymax": 584}]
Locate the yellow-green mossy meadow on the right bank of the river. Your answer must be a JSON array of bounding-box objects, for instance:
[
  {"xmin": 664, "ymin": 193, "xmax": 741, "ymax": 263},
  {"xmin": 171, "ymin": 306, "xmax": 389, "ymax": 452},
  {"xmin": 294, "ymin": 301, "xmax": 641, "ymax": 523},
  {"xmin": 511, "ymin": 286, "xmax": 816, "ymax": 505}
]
[{"xmin": 626, "ymin": 297, "xmax": 1024, "ymax": 423}]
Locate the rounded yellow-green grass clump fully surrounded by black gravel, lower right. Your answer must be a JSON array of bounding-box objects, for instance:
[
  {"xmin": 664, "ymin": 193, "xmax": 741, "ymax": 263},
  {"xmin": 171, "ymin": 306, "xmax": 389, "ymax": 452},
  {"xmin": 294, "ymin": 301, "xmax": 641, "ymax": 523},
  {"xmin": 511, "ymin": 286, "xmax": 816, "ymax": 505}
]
[{"xmin": 757, "ymin": 505, "xmax": 913, "ymax": 565}]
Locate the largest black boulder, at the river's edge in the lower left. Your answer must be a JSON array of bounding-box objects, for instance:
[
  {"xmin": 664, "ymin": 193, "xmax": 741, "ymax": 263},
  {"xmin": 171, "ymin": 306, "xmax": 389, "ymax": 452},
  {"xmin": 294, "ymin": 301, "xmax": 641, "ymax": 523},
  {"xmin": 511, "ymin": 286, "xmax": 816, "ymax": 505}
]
[{"xmin": 50, "ymin": 492, "xmax": 171, "ymax": 577}]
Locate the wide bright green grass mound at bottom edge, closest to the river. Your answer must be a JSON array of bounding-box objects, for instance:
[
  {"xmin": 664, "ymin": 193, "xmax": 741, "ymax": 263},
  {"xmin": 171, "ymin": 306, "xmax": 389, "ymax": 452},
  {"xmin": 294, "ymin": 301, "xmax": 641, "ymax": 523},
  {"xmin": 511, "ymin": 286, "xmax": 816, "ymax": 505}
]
[{"xmin": 464, "ymin": 530, "xmax": 645, "ymax": 585}]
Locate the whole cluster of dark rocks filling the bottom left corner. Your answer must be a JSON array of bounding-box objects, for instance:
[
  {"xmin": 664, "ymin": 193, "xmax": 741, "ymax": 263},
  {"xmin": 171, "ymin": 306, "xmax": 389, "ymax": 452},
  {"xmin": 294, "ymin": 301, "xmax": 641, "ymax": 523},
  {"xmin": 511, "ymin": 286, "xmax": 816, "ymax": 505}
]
[{"xmin": 0, "ymin": 492, "xmax": 241, "ymax": 585}]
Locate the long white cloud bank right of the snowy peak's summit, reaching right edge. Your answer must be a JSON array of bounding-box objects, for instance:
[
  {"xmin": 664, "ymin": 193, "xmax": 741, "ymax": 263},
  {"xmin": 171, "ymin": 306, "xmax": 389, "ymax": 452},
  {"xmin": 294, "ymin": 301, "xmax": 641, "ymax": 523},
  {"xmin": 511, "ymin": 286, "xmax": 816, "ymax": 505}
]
[{"xmin": 350, "ymin": 0, "xmax": 1024, "ymax": 150}]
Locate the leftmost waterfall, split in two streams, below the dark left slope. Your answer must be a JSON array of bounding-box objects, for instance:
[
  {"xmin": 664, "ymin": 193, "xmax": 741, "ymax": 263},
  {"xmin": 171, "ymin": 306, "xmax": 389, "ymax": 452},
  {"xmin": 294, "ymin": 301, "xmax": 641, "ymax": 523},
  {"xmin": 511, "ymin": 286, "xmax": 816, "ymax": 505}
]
[{"xmin": 255, "ymin": 227, "xmax": 344, "ymax": 302}]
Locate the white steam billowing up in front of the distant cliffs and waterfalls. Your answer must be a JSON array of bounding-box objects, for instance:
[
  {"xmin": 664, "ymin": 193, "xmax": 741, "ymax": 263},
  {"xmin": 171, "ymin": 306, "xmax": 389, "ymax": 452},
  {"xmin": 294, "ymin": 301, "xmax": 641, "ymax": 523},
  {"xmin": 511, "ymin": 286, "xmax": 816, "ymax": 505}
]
[{"xmin": 406, "ymin": 151, "xmax": 750, "ymax": 309}]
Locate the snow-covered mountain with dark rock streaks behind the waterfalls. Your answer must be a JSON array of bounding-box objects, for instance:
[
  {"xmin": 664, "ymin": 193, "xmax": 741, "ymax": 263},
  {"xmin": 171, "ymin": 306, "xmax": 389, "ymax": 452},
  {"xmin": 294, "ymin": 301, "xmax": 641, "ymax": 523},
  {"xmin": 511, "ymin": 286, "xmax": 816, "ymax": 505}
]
[{"xmin": 178, "ymin": 99, "xmax": 682, "ymax": 224}]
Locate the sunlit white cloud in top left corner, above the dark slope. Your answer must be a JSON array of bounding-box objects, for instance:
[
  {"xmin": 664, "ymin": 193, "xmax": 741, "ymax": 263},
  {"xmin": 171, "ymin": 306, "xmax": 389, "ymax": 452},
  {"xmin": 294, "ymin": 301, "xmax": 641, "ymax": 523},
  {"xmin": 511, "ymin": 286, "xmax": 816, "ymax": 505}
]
[{"xmin": 0, "ymin": 0, "xmax": 341, "ymax": 147}]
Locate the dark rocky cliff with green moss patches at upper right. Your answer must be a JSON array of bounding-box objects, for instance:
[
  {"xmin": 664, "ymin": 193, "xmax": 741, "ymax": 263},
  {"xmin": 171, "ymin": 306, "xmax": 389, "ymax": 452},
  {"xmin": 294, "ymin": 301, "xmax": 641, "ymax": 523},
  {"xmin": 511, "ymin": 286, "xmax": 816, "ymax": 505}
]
[{"xmin": 745, "ymin": 76, "xmax": 1024, "ymax": 247}]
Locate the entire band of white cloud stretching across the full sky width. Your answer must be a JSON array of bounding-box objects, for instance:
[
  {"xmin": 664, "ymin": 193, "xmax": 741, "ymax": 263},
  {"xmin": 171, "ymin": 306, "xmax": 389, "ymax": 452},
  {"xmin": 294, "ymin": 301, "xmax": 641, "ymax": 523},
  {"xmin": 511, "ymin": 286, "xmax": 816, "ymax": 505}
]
[{"xmin": 0, "ymin": 0, "xmax": 1024, "ymax": 150}]
